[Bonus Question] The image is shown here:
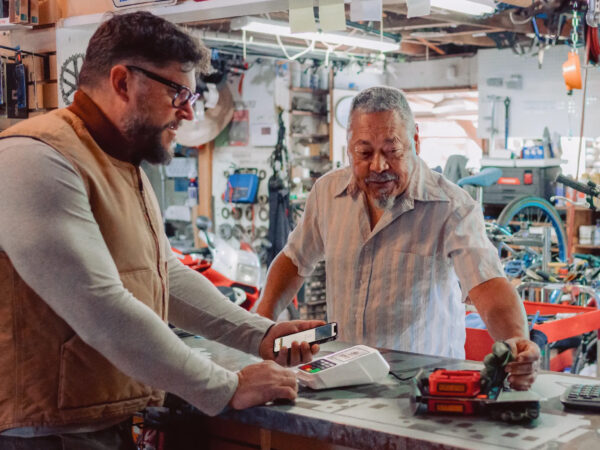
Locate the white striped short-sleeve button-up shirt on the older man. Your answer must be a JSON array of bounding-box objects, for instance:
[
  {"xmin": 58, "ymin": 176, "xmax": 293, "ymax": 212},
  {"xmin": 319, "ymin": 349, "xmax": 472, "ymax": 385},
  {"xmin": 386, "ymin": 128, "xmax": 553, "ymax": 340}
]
[{"xmin": 283, "ymin": 161, "xmax": 504, "ymax": 358}]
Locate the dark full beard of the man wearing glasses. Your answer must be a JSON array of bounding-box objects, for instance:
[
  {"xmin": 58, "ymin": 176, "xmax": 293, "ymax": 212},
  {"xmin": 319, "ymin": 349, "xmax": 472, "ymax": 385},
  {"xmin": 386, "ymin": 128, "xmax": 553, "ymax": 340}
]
[{"xmin": 124, "ymin": 116, "xmax": 172, "ymax": 164}]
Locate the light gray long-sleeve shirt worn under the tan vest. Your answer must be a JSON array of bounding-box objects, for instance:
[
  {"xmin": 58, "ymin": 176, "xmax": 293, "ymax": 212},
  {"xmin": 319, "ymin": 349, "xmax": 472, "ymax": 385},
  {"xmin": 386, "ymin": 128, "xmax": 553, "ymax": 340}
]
[{"xmin": 0, "ymin": 138, "xmax": 272, "ymax": 436}]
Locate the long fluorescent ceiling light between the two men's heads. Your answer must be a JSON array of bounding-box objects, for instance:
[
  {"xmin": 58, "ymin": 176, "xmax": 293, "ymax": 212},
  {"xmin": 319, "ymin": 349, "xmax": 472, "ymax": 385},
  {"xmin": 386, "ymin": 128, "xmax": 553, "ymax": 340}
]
[{"xmin": 231, "ymin": 17, "xmax": 400, "ymax": 52}]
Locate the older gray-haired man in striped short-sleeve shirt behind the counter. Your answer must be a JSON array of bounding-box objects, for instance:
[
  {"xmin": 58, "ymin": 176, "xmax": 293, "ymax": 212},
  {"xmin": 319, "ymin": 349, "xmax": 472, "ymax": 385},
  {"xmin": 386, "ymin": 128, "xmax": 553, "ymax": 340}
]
[{"xmin": 258, "ymin": 87, "xmax": 540, "ymax": 389}]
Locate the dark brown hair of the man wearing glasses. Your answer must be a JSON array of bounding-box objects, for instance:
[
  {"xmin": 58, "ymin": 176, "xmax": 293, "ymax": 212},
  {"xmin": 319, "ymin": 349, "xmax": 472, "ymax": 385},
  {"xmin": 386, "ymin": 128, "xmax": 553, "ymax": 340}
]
[{"xmin": 79, "ymin": 11, "xmax": 210, "ymax": 87}]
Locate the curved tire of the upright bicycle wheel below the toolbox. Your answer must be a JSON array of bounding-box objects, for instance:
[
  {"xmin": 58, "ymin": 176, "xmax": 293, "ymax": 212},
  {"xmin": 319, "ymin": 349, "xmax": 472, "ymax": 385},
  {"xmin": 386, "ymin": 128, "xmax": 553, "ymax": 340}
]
[{"xmin": 497, "ymin": 195, "xmax": 568, "ymax": 262}]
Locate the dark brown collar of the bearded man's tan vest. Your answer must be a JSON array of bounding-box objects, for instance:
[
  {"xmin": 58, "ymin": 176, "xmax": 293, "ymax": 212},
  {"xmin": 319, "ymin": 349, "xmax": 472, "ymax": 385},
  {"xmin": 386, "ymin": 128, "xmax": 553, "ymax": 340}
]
[{"xmin": 67, "ymin": 90, "xmax": 129, "ymax": 160}]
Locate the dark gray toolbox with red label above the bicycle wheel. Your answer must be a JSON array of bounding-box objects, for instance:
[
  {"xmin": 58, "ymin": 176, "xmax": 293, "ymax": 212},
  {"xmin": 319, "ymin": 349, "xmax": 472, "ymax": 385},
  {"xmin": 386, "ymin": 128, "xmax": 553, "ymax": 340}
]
[{"xmin": 482, "ymin": 165, "xmax": 561, "ymax": 205}]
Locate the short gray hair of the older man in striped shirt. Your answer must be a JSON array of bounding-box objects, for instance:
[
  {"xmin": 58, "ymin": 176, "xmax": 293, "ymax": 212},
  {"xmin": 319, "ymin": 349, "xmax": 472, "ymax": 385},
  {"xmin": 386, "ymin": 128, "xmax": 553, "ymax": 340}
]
[{"xmin": 348, "ymin": 86, "xmax": 416, "ymax": 134}]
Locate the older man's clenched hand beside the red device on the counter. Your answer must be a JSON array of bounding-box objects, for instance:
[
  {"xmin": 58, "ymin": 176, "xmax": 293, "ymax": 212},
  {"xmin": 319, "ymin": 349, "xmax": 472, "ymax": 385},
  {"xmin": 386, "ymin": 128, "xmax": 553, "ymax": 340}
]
[{"xmin": 504, "ymin": 337, "xmax": 541, "ymax": 391}]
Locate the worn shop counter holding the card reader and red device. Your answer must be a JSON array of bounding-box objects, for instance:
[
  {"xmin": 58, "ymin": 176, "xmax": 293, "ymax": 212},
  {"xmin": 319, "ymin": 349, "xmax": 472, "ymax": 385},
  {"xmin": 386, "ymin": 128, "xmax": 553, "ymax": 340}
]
[{"xmin": 179, "ymin": 338, "xmax": 600, "ymax": 450}]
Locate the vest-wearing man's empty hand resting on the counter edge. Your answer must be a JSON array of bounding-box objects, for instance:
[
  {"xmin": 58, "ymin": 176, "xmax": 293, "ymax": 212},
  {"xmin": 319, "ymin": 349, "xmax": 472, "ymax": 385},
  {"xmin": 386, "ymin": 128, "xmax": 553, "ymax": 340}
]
[{"xmin": 229, "ymin": 361, "xmax": 298, "ymax": 409}]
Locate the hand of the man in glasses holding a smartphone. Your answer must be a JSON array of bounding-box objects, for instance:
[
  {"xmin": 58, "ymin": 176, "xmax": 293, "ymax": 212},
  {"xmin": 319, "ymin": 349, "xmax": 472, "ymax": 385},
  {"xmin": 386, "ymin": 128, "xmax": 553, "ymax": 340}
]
[{"xmin": 259, "ymin": 320, "xmax": 325, "ymax": 366}]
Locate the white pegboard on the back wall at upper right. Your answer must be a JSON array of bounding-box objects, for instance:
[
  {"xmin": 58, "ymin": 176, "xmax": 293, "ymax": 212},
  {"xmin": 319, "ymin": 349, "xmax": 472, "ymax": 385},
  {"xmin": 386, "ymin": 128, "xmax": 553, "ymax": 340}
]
[{"xmin": 477, "ymin": 45, "xmax": 600, "ymax": 139}]
